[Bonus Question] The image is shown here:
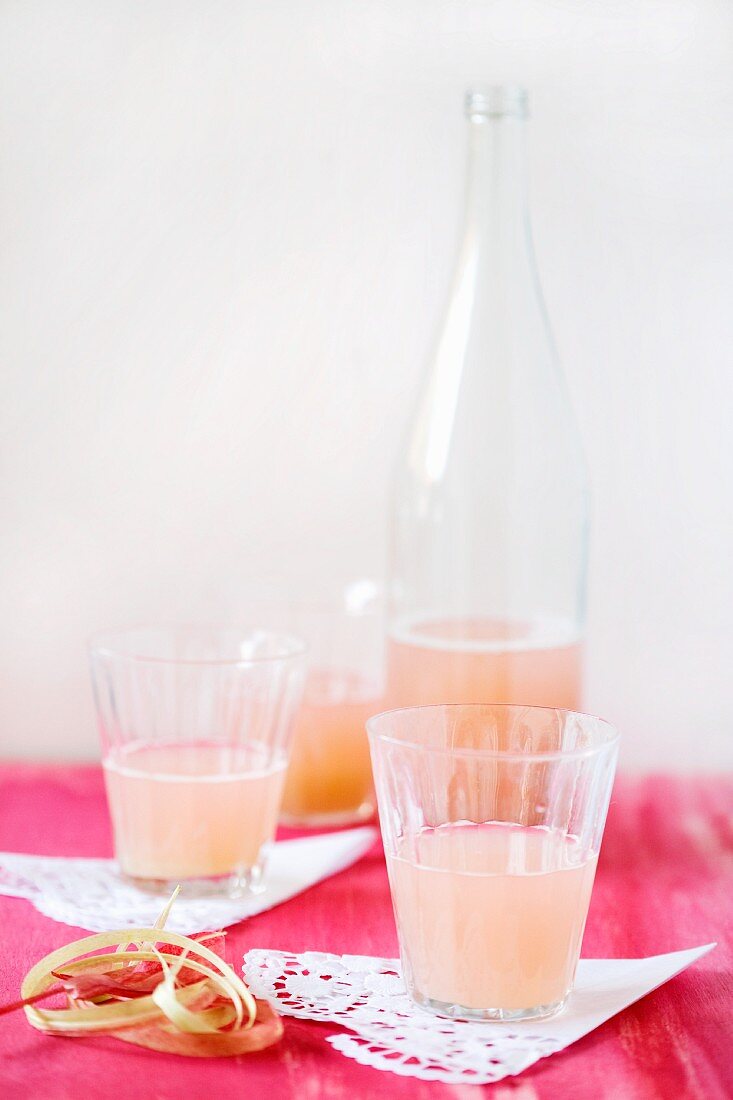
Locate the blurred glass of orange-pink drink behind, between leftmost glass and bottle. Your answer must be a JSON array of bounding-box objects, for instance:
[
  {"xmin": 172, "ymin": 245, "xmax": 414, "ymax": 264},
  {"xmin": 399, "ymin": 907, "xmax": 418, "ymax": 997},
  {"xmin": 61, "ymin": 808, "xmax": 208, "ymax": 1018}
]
[{"xmin": 281, "ymin": 582, "xmax": 384, "ymax": 826}]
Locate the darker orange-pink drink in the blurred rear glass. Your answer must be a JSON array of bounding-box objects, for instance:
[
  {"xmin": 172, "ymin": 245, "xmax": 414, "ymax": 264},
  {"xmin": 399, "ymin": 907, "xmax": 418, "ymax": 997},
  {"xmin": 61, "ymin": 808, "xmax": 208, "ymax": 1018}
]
[{"xmin": 282, "ymin": 669, "xmax": 382, "ymax": 824}]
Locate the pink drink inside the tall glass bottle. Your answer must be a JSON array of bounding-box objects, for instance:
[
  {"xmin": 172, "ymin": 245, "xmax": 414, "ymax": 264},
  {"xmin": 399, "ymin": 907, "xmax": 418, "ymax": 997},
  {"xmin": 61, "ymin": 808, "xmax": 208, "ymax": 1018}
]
[{"xmin": 387, "ymin": 619, "xmax": 581, "ymax": 711}]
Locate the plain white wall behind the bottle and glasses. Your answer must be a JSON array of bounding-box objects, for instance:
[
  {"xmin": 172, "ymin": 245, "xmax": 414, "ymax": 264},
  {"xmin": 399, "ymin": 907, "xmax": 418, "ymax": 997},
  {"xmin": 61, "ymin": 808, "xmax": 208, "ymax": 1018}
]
[{"xmin": 0, "ymin": 0, "xmax": 733, "ymax": 769}]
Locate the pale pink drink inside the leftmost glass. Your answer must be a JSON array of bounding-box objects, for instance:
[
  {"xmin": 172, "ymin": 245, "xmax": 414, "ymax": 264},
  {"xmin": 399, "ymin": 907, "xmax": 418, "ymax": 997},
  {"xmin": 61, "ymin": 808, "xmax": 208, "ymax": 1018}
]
[{"xmin": 103, "ymin": 743, "xmax": 285, "ymax": 880}]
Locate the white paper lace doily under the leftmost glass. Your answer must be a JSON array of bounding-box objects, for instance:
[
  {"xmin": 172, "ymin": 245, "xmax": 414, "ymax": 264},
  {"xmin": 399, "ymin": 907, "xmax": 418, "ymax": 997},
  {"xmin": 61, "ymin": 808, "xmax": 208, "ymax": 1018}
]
[{"xmin": 0, "ymin": 826, "xmax": 376, "ymax": 935}]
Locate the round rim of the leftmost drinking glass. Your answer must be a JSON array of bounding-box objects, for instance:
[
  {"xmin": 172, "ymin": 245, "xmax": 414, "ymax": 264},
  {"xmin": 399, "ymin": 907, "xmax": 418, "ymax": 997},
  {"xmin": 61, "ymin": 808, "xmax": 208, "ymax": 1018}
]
[{"xmin": 87, "ymin": 623, "xmax": 308, "ymax": 668}]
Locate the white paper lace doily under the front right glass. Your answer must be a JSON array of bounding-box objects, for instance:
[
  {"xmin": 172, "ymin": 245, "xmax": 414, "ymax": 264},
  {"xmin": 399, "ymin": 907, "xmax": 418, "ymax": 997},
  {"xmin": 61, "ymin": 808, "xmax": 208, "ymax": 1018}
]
[{"xmin": 243, "ymin": 945, "xmax": 713, "ymax": 1085}]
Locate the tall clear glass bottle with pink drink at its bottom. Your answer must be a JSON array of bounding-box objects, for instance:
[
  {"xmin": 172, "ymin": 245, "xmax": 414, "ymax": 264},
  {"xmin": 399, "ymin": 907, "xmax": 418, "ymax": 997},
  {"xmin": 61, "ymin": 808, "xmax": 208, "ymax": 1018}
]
[{"xmin": 387, "ymin": 87, "xmax": 588, "ymax": 708}]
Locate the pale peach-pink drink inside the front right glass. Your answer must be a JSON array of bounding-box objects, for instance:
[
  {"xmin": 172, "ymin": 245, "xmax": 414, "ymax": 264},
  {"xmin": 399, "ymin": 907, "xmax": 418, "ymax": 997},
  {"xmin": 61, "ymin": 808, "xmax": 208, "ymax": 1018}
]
[{"xmin": 387, "ymin": 823, "xmax": 597, "ymax": 1013}]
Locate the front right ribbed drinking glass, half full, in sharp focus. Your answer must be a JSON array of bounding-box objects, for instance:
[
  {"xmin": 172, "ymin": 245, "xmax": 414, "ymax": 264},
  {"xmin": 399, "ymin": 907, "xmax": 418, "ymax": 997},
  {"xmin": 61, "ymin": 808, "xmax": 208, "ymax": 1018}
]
[{"xmin": 368, "ymin": 704, "xmax": 617, "ymax": 1021}]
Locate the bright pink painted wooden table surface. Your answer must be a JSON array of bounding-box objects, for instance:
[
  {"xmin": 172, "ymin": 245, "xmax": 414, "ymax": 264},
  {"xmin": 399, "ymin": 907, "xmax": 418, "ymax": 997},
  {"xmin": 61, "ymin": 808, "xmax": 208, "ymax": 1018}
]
[{"xmin": 0, "ymin": 766, "xmax": 733, "ymax": 1100}]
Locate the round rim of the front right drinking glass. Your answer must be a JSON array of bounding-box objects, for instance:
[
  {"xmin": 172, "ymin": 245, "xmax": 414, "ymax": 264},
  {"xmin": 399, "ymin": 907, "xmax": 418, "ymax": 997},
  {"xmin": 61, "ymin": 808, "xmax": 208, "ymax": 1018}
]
[{"xmin": 367, "ymin": 703, "xmax": 621, "ymax": 760}]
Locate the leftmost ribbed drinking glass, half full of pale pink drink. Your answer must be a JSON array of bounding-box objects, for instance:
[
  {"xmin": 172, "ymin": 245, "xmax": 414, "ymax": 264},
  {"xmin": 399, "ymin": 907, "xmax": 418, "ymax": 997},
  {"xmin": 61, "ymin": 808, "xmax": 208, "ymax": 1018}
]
[{"xmin": 89, "ymin": 628, "xmax": 305, "ymax": 897}]
